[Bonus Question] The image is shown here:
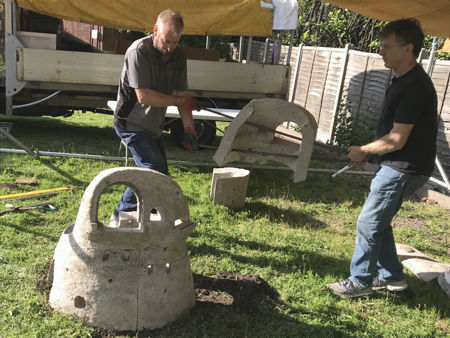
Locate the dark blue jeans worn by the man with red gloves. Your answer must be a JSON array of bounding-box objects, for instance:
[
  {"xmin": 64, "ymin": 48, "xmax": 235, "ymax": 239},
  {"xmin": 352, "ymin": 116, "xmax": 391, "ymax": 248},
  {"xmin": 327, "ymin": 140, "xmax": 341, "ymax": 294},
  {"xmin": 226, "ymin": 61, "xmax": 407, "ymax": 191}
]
[{"xmin": 114, "ymin": 125, "xmax": 168, "ymax": 216}]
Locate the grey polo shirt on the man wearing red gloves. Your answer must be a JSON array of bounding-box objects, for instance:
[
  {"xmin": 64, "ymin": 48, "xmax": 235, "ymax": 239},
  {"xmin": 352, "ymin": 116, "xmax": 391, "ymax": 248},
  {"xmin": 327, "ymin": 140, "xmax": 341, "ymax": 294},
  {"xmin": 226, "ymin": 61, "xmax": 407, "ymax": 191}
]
[{"xmin": 114, "ymin": 35, "xmax": 187, "ymax": 138}]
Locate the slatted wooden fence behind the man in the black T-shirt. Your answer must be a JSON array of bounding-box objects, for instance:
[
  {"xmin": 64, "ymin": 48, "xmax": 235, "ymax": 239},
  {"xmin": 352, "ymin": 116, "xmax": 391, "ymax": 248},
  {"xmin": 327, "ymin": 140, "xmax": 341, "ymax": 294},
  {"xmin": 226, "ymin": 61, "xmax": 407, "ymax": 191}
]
[{"xmin": 282, "ymin": 46, "xmax": 450, "ymax": 175}]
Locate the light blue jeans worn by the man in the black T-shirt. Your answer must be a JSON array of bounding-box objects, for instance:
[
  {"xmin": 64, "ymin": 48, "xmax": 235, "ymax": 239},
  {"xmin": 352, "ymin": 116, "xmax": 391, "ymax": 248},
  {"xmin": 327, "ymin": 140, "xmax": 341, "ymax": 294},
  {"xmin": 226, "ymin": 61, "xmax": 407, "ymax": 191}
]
[{"xmin": 350, "ymin": 165, "xmax": 428, "ymax": 287}]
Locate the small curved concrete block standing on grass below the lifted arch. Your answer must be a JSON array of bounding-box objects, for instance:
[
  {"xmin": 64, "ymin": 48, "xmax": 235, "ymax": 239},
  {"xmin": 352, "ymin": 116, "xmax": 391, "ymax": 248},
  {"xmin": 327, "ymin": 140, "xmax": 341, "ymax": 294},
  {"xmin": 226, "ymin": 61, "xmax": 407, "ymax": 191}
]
[{"xmin": 209, "ymin": 167, "xmax": 250, "ymax": 209}]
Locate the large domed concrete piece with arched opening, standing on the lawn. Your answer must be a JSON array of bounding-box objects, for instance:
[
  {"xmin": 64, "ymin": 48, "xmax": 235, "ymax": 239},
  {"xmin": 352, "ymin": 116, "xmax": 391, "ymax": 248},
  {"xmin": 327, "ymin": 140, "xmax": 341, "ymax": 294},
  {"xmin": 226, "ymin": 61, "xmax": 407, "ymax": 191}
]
[{"xmin": 50, "ymin": 168, "xmax": 195, "ymax": 331}]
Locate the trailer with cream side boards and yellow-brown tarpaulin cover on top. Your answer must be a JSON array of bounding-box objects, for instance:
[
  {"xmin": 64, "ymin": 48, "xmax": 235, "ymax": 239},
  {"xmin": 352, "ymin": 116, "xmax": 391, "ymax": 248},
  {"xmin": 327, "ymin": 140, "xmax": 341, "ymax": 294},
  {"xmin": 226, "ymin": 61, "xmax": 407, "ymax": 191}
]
[{"xmin": 1, "ymin": 0, "xmax": 297, "ymax": 144}]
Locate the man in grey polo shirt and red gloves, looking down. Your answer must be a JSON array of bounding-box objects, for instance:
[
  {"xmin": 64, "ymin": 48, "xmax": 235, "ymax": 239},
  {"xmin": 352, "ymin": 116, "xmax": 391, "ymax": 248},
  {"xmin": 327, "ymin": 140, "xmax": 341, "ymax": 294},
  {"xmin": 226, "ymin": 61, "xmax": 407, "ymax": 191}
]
[{"xmin": 111, "ymin": 9, "xmax": 198, "ymax": 221}]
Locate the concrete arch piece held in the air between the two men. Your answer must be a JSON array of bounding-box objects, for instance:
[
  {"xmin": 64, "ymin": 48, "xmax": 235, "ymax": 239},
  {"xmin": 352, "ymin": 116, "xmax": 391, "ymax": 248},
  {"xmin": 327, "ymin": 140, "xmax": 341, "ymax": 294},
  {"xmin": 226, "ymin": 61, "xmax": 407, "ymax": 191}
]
[{"xmin": 214, "ymin": 98, "xmax": 317, "ymax": 182}]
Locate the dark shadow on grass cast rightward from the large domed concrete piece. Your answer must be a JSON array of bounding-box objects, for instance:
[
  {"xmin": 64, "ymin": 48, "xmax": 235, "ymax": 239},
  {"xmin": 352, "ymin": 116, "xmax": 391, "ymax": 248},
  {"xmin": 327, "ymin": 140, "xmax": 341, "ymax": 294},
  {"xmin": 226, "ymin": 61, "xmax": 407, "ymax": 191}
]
[{"xmin": 108, "ymin": 271, "xmax": 361, "ymax": 337}]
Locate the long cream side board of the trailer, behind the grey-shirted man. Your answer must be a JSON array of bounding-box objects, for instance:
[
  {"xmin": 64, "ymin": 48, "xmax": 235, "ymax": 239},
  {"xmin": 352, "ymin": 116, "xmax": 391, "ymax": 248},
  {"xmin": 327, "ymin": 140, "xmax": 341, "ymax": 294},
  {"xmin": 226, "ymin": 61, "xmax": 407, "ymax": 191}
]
[{"xmin": 18, "ymin": 48, "xmax": 288, "ymax": 95}]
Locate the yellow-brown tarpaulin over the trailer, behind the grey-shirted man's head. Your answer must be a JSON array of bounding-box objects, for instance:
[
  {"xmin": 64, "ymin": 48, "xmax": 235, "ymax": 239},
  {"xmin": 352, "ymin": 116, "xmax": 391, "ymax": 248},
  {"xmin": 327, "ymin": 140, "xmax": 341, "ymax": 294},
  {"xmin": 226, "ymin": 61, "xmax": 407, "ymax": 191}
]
[{"xmin": 16, "ymin": 0, "xmax": 273, "ymax": 36}]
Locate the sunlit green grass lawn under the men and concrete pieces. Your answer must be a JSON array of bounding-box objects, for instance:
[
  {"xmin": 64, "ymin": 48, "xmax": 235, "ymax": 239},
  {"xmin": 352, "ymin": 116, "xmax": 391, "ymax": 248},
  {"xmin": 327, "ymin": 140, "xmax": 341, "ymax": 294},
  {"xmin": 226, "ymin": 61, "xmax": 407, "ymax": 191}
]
[{"xmin": 0, "ymin": 113, "xmax": 450, "ymax": 337}]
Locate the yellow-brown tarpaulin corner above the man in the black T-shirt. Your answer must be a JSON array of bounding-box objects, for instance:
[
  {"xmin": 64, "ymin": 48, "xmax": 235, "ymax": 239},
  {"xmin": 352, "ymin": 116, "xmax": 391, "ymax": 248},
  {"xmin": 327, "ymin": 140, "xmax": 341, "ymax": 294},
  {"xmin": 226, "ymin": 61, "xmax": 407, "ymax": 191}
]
[{"xmin": 326, "ymin": 0, "xmax": 450, "ymax": 37}]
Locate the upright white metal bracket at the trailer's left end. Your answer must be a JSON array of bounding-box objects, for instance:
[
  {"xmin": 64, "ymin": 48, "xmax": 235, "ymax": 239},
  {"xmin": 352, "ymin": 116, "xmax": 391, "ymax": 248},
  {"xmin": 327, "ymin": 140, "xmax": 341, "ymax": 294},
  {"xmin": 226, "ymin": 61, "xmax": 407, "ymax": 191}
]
[{"xmin": 5, "ymin": 33, "xmax": 27, "ymax": 97}]
